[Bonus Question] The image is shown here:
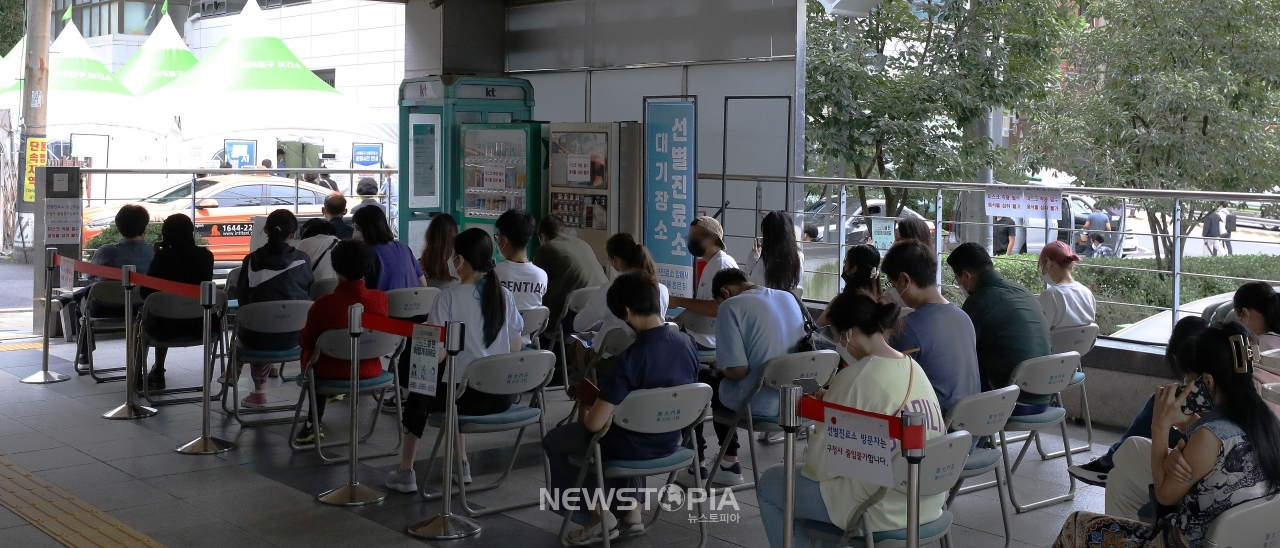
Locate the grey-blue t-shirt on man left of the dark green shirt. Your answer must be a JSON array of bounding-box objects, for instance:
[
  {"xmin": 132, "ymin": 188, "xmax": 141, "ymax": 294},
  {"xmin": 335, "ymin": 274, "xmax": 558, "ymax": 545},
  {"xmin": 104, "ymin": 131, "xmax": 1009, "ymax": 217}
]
[{"xmin": 890, "ymin": 302, "xmax": 982, "ymax": 412}]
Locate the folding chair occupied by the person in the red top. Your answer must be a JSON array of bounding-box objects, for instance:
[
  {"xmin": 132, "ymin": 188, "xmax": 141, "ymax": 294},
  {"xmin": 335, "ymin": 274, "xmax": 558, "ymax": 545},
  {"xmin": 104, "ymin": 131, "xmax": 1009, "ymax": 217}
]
[{"xmin": 289, "ymin": 329, "xmax": 404, "ymax": 465}]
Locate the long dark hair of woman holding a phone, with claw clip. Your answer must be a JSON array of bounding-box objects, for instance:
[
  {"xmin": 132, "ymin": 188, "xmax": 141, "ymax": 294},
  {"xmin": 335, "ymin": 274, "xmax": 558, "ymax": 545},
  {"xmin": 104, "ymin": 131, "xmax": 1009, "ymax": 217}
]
[{"xmin": 1187, "ymin": 321, "xmax": 1280, "ymax": 489}]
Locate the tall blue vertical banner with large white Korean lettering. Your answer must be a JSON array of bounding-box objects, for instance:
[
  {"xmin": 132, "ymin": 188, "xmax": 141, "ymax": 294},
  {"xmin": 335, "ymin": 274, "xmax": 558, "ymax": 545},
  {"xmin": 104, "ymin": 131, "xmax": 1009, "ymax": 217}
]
[{"xmin": 644, "ymin": 100, "xmax": 698, "ymax": 297}]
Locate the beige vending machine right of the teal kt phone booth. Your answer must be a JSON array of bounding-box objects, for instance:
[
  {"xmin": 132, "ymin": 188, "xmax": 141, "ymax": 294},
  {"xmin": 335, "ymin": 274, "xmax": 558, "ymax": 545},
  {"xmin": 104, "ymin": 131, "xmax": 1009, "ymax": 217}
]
[{"xmin": 547, "ymin": 122, "xmax": 644, "ymax": 266}]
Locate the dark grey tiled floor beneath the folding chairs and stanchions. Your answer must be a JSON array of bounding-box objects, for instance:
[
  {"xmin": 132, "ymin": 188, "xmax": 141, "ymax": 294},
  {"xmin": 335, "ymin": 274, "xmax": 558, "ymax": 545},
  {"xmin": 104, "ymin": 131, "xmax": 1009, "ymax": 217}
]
[{"xmin": 0, "ymin": 339, "xmax": 1116, "ymax": 548}]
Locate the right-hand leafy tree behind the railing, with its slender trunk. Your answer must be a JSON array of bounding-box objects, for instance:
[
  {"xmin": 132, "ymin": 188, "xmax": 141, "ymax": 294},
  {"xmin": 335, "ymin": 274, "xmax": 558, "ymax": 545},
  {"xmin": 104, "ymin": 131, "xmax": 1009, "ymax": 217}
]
[{"xmin": 1021, "ymin": 0, "xmax": 1280, "ymax": 268}]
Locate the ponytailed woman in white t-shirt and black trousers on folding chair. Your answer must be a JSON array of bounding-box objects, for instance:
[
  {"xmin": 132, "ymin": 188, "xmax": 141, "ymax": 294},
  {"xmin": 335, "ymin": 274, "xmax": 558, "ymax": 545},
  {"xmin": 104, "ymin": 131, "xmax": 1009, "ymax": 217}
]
[{"xmin": 389, "ymin": 229, "xmax": 525, "ymax": 493}]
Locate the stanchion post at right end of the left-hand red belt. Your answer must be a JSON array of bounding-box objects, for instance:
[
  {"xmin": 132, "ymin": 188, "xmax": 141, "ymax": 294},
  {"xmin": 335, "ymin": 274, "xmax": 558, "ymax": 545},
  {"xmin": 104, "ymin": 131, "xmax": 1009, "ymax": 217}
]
[{"xmin": 408, "ymin": 321, "xmax": 480, "ymax": 540}]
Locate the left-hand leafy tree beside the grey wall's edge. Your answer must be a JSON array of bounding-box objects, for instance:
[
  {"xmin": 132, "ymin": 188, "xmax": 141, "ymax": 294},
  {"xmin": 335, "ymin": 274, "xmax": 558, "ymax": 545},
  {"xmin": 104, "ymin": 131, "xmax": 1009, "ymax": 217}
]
[{"xmin": 805, "ymin": 0, "xmax": 1073, "ymax": 214}]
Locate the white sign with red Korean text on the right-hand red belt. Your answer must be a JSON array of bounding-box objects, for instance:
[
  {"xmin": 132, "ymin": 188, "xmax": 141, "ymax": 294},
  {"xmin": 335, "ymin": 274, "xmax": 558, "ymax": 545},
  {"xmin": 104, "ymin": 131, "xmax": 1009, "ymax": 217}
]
[{"xmin": 824, "ymin": 407, "xmax": 893, "ymax": 488}]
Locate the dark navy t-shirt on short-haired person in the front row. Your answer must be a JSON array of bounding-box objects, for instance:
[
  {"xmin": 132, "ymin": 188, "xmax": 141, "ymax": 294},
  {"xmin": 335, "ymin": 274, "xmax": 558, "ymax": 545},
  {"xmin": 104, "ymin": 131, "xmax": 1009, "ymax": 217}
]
[{"xmin": 600, "ymin": 326, "xmax": 698, "ymax": 460}]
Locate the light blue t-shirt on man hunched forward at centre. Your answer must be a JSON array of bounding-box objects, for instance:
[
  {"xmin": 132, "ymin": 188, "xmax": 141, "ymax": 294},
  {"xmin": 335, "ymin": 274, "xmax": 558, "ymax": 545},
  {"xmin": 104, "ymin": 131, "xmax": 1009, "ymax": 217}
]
[{"xmin": 716, "ymin": 287, "xmax": 805, "ymax": 416}]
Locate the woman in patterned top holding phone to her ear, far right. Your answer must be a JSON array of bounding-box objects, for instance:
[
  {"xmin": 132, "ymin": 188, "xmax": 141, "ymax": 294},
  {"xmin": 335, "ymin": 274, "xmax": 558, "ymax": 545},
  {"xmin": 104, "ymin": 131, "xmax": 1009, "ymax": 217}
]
[{"xmin": 1053, "ymin": 323, "xmax": 1280, "ymax": 548}]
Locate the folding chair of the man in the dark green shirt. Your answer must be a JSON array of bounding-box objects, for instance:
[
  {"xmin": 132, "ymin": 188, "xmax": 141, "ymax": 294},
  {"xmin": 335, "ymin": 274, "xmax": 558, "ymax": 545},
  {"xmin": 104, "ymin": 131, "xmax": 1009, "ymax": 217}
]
[{"xmin": 1000, "ymin": 352, "xmax": 1080, "ymax": 513}]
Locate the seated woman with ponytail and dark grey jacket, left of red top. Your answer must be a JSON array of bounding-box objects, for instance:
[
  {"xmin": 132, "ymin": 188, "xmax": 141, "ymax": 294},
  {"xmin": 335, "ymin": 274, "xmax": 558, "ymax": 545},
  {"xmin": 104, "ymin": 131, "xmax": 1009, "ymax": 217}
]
[{"xmin": 234, "ymin": 209, "xmax": 315, "ymax": 407}]
